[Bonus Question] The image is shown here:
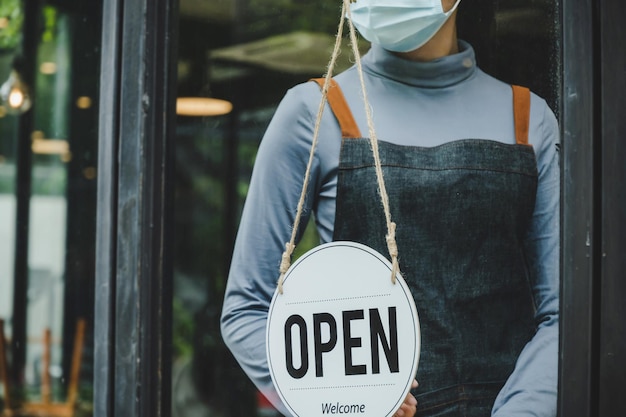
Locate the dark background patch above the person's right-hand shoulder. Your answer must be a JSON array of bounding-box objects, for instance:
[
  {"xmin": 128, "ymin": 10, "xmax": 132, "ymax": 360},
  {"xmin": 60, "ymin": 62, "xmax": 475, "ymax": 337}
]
[{"xmin": 457, "ymin": 0, "xmax": 561, "ymax": 118}]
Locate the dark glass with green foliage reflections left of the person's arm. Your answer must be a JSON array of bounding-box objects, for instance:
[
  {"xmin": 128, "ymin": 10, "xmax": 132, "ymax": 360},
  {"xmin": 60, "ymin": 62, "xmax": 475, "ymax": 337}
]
[{"xmin": 172, "ymin": 0, "xmax": 344, "ymax": 417}]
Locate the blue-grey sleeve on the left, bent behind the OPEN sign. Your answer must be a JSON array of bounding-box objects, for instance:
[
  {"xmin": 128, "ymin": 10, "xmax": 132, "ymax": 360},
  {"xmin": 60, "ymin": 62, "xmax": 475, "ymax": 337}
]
[{"xmin": 222, "ymin": 86, "xmax": 332, "ymax": 415}]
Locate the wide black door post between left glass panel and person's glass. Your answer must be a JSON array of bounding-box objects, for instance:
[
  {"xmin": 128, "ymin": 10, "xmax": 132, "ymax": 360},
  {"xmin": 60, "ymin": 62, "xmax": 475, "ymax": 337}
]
[{"xmin": 94, "ymin": 0, "xmax": 178, "ymax": 417}]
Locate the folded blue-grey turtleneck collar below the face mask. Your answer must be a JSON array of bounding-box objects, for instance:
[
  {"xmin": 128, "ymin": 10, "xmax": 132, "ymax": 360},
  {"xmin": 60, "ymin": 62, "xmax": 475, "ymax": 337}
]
[{"xmin": 362, "ymin": 40, "xmax": 476, "ymax": 88}]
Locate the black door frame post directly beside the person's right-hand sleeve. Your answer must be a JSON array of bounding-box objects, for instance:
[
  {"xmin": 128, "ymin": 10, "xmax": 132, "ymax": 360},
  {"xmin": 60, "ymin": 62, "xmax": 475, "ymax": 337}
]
[{"xmin": 559, "ymin": 0, "xmax": 598, "ymax": 416}]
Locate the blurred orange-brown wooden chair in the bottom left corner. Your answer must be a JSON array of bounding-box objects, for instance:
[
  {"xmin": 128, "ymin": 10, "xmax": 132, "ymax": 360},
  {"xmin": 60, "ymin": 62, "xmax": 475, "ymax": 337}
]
[{"xmin": 0, "ymin": 319, "xmax": 86, "ymax": 417}]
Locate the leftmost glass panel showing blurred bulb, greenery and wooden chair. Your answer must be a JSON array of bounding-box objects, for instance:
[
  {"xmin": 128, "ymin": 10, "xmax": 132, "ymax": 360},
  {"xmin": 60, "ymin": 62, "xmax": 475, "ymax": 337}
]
[{"xmin": 0, "ymin": 0, "xmax": 101, "ymax": 416}]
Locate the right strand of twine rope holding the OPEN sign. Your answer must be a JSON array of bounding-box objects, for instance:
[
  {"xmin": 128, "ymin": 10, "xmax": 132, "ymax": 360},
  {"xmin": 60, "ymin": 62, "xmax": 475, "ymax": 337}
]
[{"xmin": 344, "ymin": 0, "xmax": 400, "ymax": 284}]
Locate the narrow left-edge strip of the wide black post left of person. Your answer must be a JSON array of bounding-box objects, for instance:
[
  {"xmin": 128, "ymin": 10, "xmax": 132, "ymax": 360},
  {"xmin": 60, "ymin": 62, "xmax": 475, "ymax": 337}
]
[{"xmin": 93, "ymin": 1, "xmax": 122, "ymax": 417}]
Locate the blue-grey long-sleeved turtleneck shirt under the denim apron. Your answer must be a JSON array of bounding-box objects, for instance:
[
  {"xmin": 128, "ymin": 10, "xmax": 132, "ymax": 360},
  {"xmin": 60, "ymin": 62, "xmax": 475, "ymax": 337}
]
[{"xmin": 222, "ymin": 41, "xmax": 560, "ymax": 417}]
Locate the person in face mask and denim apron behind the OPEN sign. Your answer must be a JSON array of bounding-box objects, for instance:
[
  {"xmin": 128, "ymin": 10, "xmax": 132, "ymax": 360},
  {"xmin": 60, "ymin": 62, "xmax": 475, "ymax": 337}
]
[{"xmin": 222, "ymin": 0, "xmax": 559, "ymax": 417}]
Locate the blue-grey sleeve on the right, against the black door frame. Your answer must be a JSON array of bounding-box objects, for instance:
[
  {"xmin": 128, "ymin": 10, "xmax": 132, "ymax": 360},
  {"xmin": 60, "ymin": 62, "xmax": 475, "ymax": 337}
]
[{"xmin": 492, "ymin": 101, "xmax": 560, "ymax": 417}]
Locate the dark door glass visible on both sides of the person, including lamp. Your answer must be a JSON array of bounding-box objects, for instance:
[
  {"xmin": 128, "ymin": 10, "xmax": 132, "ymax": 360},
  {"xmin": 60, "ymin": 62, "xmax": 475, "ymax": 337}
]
[{"xmin": 172, "ymin": 0, "xmax": 559, "ymax": 417}]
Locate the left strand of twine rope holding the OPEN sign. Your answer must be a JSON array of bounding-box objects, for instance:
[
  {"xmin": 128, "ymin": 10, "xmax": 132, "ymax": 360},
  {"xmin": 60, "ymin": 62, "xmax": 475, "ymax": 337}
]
[{"xmin": 277, "ymin": 0, "xmax": 349, "ymax": 294}]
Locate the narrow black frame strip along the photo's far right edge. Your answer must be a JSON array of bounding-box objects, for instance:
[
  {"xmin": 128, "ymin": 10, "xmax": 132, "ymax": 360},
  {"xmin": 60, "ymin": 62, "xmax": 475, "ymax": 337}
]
[{"xmin": 596, "ymin": 0, "xmax": 626, "ymax": 417}]
